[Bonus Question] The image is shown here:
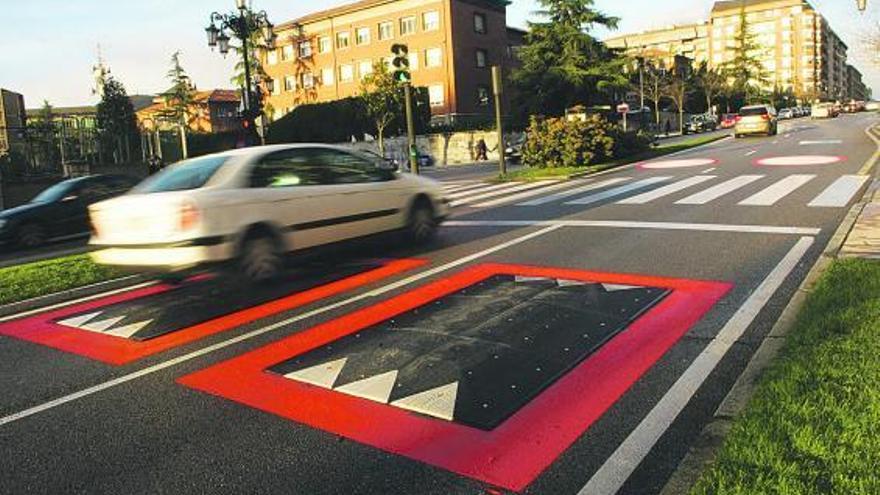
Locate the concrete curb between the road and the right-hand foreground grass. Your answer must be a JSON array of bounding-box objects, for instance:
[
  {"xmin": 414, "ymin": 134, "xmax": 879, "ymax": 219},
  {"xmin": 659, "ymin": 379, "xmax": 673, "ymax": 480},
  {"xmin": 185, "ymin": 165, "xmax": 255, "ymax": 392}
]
[{"xmin": 660, "ymin": 124, "xmax": 880, "ymax": 495}]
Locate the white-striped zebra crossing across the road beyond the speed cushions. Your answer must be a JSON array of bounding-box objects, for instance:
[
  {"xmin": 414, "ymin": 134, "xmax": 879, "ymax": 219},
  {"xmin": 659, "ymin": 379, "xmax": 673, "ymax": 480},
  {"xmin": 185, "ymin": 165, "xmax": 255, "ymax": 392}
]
[{"xmin": 443, "ymin": 173, "xmax": 868, "ymax": 208}]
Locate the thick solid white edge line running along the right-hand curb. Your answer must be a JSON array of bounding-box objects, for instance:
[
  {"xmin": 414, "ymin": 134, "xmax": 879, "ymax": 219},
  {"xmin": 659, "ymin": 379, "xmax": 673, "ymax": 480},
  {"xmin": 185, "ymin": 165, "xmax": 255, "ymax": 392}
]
[{"xmin": 578, "ymin": 237, "xmax": 814, "ymax": 495}]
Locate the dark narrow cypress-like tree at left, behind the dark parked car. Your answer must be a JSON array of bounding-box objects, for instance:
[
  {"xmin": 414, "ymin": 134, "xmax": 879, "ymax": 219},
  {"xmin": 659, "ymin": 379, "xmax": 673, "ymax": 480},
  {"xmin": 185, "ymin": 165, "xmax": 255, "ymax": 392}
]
[{"xmin": 97, "ymin": 76, "xmax": 138, "ymax": 163}]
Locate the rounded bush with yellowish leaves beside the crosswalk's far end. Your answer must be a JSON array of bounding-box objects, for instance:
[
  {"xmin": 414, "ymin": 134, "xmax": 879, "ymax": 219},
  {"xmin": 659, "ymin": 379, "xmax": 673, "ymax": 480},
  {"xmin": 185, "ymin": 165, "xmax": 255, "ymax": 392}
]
[{"xmin": 523, "ymin": 115, "xmax": 616, "ymax": 168}]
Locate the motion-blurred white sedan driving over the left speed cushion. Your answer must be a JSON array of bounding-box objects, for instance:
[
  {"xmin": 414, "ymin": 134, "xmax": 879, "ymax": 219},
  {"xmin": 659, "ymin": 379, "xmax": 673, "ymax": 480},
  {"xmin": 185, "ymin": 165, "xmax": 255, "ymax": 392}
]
[{"xmin": 89, "ymin": 144, "xmax": 449, "ymax": 281}]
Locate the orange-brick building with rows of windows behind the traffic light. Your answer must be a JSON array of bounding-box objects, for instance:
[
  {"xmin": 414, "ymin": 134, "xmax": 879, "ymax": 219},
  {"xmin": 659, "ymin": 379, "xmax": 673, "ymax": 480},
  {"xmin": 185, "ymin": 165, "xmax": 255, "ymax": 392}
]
[{"xmin": 261, "ymin": 0, "xmax": 525, "ymax": 123}]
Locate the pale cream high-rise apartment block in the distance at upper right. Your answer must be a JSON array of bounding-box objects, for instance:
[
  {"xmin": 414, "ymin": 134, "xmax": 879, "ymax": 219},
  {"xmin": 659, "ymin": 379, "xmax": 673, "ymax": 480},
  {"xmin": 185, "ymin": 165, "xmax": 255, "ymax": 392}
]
[{"xmin": 606, "ymin": 0, "xmax": 868, "ymax": 101}]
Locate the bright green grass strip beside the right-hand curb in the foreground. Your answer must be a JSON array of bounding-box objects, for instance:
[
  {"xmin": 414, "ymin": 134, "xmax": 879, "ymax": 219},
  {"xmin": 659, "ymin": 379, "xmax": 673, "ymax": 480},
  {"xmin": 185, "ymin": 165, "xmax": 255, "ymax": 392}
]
[{"xmin": 691, "ymin": 260, "xmax": 880, "ymax": 495}]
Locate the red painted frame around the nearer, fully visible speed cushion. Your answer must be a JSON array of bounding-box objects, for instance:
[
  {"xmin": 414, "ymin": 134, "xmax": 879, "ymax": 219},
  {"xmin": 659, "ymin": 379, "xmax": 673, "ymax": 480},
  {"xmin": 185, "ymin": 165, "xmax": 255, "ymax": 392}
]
[{"xmin": 178, "ymin": 264, "xmax": 731, "ymax": 491}]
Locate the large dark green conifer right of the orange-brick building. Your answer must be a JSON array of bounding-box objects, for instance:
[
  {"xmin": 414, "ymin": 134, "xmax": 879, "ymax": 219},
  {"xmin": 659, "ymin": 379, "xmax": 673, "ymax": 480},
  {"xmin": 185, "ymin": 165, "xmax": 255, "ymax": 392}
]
[{"xmin": 511, "ymin": 0, "xmax": 627, "ymax": 115}]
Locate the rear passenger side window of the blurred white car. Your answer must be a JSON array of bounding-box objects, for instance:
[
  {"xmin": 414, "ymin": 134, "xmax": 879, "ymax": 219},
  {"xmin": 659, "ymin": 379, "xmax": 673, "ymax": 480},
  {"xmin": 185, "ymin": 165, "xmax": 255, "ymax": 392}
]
[{"xmin": 249, "ymin": 148, "xmax": 330, "ymax": 188}]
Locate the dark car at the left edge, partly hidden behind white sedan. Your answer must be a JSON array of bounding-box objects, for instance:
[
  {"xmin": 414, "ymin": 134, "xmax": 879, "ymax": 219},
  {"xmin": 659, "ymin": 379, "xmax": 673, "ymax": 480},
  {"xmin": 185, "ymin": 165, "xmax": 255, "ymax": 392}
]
[{"xmin": 0, "ymin": 175, "xmax": 138, "ymax": 248}]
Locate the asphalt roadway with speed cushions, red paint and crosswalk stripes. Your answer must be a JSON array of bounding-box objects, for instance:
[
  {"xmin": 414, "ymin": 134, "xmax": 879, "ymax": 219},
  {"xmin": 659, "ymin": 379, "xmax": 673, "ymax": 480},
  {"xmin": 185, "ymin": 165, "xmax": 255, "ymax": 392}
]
[{"xmin": 0, "ymin": 114, "xmax": 877, "ymax": 494}]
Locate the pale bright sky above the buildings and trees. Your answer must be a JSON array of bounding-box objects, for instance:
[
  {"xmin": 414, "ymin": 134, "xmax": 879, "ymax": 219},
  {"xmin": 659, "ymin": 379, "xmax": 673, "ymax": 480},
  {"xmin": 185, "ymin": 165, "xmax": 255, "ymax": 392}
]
[{"xmin": 0, "ymin": 0, "xmax": 880, "ymax": 107}]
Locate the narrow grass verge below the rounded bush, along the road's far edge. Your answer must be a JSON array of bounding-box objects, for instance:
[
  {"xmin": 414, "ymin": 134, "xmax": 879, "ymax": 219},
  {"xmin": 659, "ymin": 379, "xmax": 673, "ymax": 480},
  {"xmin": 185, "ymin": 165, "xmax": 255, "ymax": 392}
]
[{"xmin": 495, "ymin": 134, "xmax": 727, "ymax": 182}]
